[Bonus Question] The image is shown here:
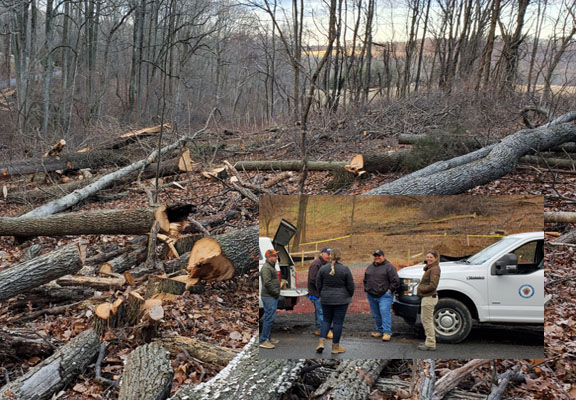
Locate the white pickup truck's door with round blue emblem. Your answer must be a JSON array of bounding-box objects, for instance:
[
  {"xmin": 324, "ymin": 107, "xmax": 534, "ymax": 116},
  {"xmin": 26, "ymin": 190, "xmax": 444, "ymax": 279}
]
[{"xmin": 488, "ymin": 240, "xmax": 544, "ymax": 323}]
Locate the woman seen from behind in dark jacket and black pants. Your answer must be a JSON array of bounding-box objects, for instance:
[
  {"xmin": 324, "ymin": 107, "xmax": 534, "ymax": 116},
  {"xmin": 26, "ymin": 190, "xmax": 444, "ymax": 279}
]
[{"xmin": 316, "ymin": 249, "xmax": 354, "ymax": 354}]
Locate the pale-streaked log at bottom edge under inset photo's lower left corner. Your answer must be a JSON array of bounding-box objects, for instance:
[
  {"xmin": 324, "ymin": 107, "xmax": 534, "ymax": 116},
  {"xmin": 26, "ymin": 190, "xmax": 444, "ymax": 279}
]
[{"xmin": 170, "ymin": 338, "xmax": 304, "ymax": 400}]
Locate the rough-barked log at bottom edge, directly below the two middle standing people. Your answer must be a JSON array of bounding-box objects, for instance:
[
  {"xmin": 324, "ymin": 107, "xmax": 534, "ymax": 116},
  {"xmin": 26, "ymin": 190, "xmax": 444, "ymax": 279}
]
[{"xmin": 312, "ymin": 360, "xmax": 389, "ymax": 400}]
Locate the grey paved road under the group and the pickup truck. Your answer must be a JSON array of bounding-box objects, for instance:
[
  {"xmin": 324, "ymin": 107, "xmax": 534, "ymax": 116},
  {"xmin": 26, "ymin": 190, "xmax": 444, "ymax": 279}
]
[{"xmin": 260, "ymin": 313, "xmax": 544, "ymax": 359}]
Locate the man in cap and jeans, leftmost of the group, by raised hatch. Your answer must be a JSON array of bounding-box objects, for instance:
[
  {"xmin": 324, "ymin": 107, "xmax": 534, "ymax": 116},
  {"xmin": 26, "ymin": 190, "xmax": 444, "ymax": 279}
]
[{"xmin": 260, "ymin": 249, "xmax": 280, "ymax": 349}]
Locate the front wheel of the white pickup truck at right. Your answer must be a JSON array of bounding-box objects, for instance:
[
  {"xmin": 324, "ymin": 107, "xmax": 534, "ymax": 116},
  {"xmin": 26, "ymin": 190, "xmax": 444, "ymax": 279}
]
[{"xmin": 434, "ymin": 298, "xmax": 472, "ymax": 343}]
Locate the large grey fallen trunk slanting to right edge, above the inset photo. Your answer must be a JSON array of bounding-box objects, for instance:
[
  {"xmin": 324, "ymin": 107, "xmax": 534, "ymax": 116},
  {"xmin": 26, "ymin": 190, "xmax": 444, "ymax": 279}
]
[{"xmin": 363, "ymin": 111, "xmax": 576, "ymax": 195}]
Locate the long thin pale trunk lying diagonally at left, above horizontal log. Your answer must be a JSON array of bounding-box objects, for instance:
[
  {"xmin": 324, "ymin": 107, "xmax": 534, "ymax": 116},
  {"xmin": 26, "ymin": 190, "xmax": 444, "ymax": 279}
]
[{"xmin": 19, "ymin": 113, "xmax": 213, "ymax": 217}]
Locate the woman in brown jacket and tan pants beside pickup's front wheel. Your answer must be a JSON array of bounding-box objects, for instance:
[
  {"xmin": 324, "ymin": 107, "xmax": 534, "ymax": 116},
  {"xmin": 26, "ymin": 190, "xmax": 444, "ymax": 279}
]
[{"xmin": 417, "ymin": 250, "xmax": 440, "ymax": 351}]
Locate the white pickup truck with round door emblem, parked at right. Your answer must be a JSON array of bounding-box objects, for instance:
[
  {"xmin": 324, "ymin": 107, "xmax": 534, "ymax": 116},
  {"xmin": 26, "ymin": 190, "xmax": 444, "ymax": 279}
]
[{"xmin": 393, "ymin": 232, "xmax": 544, "ymax": 343}]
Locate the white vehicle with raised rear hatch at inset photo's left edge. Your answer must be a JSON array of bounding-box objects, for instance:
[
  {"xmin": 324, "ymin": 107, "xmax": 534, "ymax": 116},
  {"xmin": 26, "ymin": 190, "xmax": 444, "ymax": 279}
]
[{"xmin": 258, "ymin": 219, "xmax": 308, "ymax": 317}]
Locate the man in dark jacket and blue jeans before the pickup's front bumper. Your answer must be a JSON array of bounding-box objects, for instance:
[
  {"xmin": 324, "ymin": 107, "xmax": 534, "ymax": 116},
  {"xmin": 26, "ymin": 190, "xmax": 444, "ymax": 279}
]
[{"xmin": 364, "ymin": 250, "xmax": 400, "ymax": 342}]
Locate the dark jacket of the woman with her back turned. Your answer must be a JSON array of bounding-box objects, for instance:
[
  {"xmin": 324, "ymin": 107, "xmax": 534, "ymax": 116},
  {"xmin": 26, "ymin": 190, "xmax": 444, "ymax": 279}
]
[{"xmin": 316, "ymin": 263, "xmax": 354, "ymax": 306}]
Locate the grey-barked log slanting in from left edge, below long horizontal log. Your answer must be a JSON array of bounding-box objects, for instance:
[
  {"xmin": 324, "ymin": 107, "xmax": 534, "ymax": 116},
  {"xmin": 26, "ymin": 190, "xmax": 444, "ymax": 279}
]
[{"xmin": 0, "ymin": 243, "xmax": 86, "ymax": 301}]
